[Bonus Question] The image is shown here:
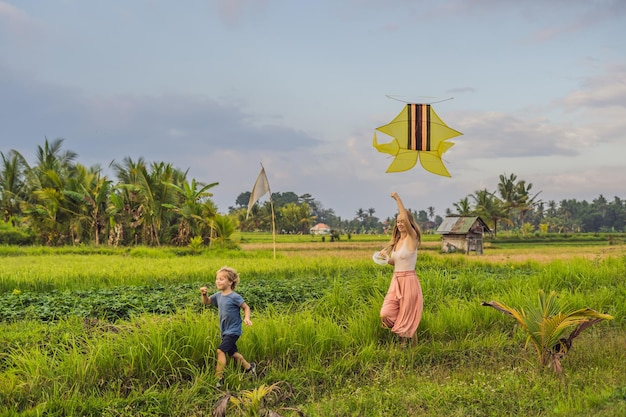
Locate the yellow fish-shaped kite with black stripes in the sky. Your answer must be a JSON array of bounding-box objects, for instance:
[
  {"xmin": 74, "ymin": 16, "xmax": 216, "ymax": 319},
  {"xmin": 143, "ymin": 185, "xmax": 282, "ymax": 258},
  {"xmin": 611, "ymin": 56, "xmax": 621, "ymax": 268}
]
[{"xmin": 373, "ymin": 104, "xmax": 462, "ymax": 177}]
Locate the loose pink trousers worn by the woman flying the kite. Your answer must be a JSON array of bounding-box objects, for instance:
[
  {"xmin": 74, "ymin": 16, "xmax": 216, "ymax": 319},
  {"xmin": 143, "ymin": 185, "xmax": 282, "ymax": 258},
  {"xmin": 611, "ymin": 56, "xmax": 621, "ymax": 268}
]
[{"xmin": 380, "ymin": 271, "xmax": 424, "ymax": 337}]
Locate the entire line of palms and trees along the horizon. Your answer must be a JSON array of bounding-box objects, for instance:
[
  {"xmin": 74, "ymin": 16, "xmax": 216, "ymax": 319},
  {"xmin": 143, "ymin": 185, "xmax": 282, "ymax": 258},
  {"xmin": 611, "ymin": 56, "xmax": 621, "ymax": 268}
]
[{"xmin": 0, "ymin": 139, "xmax": 626, "ymax": 246}]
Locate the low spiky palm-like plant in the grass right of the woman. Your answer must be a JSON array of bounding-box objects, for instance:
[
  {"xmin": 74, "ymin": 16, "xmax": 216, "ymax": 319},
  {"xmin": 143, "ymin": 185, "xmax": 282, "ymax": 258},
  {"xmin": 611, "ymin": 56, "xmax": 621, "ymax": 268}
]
[{"xmin": 482, "ymin": 290, "xmax": 613, "ymax": 373}]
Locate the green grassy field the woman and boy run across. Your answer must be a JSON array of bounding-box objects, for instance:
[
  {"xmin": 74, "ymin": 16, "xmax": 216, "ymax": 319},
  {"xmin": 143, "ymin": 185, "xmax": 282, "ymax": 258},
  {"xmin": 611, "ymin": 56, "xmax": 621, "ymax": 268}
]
[{"xmin": 0, "ymin": 234, "xmax": 626, "ymax": 417}]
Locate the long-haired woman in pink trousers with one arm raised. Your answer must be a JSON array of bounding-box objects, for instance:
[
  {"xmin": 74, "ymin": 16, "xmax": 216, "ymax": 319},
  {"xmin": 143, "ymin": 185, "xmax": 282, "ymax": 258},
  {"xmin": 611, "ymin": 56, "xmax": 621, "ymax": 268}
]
[{"xmin": 380, "ymin": 192, "xmax": 423, "ymax": 344}]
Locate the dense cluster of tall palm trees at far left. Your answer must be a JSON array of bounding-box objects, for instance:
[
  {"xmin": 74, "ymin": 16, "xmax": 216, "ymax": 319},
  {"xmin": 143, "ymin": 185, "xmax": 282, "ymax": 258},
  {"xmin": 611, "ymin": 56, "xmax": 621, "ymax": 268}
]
[{"xmin": 0, "ymin": 139, "xmax": 224, "ymax": 246}]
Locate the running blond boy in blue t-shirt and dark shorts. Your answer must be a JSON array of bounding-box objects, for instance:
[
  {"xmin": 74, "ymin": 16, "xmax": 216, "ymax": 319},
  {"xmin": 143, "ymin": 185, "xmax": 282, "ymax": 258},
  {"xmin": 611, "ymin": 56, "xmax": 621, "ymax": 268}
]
[{"xmin": 200, "ymin": 266, "xmax": 256, "ymax": 387}]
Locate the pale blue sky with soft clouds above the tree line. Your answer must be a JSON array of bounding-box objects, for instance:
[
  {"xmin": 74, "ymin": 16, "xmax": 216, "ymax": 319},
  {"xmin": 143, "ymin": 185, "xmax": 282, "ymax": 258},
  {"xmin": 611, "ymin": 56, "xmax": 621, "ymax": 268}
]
[{"xmin": 0, "ymin": 0, "xmax": 626, "ymax": 219}]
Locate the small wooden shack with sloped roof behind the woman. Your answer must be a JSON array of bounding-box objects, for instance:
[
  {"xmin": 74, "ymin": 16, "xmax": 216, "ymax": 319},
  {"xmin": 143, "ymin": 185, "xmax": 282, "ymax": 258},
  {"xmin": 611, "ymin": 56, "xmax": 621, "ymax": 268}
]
[{"xmin": 436, "ymin": 217, "xmax": 491, "ymax": 255}]
